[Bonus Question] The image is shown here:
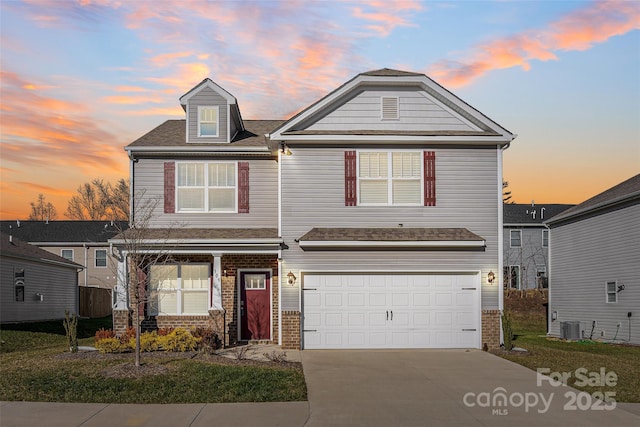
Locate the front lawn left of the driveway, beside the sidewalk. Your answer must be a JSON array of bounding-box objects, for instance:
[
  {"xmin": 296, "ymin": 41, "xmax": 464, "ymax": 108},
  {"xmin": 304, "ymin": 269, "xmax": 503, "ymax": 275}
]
[{"xmin": 0, "ymin": 320, "xmax": 306, "ymax": 403}]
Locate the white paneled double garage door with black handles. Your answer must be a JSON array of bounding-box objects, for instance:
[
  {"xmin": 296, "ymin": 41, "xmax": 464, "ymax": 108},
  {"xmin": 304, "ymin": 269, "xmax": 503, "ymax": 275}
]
[{"xmin": 303, "ymin": 273, "xmax": 480, "ymax": 349}]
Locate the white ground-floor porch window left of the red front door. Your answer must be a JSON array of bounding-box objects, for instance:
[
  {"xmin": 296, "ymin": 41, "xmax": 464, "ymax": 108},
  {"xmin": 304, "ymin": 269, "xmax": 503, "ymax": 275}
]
[{"xmin": 149, "ymin": 264, "xmax": 210, "ymax": 316}]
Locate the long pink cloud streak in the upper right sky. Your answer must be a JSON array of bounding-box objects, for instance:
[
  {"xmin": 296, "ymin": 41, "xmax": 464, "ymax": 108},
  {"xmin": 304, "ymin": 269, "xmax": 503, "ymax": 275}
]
[{"xmin": 428, "ymin": 1, "xmax": 640, "ymax": 87}]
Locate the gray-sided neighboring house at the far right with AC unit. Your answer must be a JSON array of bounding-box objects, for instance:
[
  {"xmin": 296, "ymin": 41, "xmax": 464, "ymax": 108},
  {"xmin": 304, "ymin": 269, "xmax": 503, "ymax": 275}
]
[{"xmin": 546, "ymin": 175, "xmax": 640, "ymax": 344}]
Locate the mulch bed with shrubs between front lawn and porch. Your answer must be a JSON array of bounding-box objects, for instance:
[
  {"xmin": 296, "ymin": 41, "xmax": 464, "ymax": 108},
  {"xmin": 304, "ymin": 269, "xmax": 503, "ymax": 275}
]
[{"xmin": 53, "ymin": 351, "xmax": 302, "ymax": 378}]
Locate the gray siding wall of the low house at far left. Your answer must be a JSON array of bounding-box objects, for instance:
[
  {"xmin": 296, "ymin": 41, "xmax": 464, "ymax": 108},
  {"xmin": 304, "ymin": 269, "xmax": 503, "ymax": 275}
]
[{"xmin": 0, "ymin": 257, "xmax": 78, "ymax": 322}]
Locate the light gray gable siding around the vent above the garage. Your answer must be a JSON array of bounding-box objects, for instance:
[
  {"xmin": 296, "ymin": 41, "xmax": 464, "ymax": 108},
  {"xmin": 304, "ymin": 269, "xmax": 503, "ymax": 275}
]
[{"xmin": 307, "ymin": 88, "xmax": 479, "ymax": 131}]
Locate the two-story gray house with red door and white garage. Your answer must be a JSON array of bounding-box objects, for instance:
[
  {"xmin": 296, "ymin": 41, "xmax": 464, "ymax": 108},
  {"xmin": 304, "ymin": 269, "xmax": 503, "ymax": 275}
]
[{"xmin": 111, "ymin": 69, "xmax": 514, "ymax": 349}]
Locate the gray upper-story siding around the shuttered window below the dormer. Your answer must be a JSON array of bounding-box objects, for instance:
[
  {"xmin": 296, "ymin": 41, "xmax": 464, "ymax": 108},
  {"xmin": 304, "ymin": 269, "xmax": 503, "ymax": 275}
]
[{"xmin": 134, "ymin": 158, "xmax": 278, "ymax": 228}]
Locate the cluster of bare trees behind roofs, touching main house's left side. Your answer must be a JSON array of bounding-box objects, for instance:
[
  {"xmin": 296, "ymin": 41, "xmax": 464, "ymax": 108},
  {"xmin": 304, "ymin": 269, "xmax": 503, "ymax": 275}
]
[{"xmin": 65, "ymin": 178, "xmax": 129, "ymax": 221}]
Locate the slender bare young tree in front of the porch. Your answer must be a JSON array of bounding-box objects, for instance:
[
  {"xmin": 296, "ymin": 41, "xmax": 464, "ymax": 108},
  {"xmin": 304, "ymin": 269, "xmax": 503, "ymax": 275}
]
[{"xmin": 111, "ymin": 197, "xmax": 175, "ymax": 366}]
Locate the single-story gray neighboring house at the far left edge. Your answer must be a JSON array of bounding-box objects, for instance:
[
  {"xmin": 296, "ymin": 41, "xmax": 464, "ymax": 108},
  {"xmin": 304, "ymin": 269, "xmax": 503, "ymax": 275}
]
[{"xmin": 0, "ymin": 233, "xmax": 82, "ymax": 323}]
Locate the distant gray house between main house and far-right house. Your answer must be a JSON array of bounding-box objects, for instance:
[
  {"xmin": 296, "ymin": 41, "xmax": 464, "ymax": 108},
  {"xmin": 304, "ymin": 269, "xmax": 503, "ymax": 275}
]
[{"xmin": 502, "ymin": 202, "xmax": 574, "ymax": 289}]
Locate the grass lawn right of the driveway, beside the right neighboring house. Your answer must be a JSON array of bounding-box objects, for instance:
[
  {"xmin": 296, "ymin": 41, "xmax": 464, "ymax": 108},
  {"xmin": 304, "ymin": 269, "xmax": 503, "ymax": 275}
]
[{"xmin": 499, "ymin": 311, "xmax": 640, "ymax": 403}]
